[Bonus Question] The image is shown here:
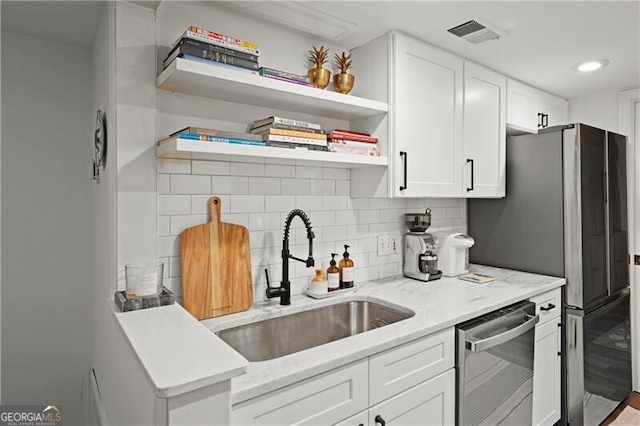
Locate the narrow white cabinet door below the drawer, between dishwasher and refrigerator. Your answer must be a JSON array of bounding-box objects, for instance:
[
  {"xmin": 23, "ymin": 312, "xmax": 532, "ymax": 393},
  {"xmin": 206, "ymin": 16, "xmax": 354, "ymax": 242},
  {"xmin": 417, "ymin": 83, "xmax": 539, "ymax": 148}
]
[{"xmin": 532, "ymin": 317, "xmax": 561, "ymax": 426}]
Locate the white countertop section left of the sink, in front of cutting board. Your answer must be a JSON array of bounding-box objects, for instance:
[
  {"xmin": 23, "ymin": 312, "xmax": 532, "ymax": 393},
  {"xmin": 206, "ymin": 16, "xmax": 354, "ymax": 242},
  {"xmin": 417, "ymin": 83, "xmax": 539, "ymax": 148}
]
[{"xmin": 114, "ymin": 304, "xmax": 248, "ymax": 398}]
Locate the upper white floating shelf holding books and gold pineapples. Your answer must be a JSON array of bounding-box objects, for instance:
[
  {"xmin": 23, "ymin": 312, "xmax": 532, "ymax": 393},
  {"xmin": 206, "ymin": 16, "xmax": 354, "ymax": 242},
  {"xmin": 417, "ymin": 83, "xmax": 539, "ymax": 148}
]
[{"xmin": 157, "ymin": 58, "xmax": 389, "ymax": 120}]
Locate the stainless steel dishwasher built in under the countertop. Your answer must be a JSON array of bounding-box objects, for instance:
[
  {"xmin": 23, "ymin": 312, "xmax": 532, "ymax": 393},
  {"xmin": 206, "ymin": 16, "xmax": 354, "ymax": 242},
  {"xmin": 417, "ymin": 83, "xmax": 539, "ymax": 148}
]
[{"xmin": 456, "ymin": 301, "xmax": 539, "ymax": 426}]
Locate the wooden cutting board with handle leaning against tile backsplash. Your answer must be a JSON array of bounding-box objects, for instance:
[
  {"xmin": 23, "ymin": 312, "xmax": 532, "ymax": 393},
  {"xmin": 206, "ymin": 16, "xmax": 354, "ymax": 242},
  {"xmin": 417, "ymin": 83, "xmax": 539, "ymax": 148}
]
[{"xmin": 181, "ymin": 197, "xmax": 253, "ymax": 320}]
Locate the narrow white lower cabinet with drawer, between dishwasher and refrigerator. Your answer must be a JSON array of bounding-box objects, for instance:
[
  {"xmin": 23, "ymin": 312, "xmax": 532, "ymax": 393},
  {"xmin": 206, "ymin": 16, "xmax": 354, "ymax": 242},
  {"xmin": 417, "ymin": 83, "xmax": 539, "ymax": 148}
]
[{"xmin": 531, "ymin": 289, "xmax": 562, "ymax": 426}]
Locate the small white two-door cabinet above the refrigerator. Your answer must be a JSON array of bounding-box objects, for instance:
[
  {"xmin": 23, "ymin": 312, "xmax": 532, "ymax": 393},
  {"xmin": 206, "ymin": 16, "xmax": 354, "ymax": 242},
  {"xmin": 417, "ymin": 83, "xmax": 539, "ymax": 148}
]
[{"xmin": 507, "ymin": 79, "xmax": 568, "ymax": 133}]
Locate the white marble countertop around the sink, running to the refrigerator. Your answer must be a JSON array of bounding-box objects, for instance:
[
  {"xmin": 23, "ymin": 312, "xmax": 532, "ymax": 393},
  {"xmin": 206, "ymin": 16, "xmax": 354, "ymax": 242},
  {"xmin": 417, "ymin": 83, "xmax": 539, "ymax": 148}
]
[{"xmin": 202, "ymin": 265, "xmax": 565, "ymax": 404}]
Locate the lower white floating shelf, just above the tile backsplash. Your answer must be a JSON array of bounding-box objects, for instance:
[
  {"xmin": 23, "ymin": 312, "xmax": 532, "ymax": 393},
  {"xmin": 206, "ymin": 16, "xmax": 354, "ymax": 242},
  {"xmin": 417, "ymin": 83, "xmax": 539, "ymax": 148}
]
[{"xmin": 156, "ymin": 139, "xmax": 387, "ymax": 168}]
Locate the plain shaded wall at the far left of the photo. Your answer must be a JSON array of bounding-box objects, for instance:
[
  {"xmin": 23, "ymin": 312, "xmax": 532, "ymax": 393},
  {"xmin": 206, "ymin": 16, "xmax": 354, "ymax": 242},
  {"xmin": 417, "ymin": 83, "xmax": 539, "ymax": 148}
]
[{"xmin": 1, "ymin": 32, "xmax": 94, "ymax": 424}]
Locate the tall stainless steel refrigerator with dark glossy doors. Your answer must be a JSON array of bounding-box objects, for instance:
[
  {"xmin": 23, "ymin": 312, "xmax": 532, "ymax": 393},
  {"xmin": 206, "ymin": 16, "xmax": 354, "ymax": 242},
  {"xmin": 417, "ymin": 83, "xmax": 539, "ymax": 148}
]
[{"xmin": 468, "ymin": 123, "xmax": 631, "ymax": 425}]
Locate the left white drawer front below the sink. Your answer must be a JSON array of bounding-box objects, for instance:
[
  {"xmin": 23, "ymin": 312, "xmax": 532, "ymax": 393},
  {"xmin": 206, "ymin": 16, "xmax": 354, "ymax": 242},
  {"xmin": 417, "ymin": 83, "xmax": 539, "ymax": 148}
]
[{"xmin": 231, "ymin": 360, "xmax": 369, "ymax": 426}]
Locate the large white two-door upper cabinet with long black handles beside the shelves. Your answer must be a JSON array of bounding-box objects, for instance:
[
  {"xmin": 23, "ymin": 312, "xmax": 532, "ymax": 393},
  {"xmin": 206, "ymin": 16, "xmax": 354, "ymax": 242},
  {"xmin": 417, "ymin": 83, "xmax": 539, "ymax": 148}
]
[{"xmin": 351, "ymin": 32, "xmax": 506, "ymax": 198}]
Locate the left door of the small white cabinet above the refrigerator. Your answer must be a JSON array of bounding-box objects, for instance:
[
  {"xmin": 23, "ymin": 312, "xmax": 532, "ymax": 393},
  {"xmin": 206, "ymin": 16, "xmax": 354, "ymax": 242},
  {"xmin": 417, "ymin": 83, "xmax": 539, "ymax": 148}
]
[{"xmin": 507, "ymin": 79, "xmax": 538, "ymax": 133}]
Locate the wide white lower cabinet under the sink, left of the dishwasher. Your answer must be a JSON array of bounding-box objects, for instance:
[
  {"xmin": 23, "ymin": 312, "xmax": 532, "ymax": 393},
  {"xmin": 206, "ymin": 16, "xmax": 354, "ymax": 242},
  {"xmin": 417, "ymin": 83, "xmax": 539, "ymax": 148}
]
[{"xmin": 231, "ymin": 327, "xmax": 455, "ymax": 426}]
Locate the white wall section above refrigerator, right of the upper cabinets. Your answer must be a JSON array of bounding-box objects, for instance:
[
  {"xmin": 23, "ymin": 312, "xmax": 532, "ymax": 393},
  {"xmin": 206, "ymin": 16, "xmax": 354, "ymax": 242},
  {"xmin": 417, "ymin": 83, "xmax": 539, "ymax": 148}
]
[{"xmin": 569, "ymin": 90, "xmax": 620, "ymax": 132}]
